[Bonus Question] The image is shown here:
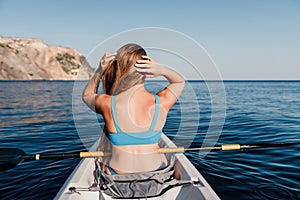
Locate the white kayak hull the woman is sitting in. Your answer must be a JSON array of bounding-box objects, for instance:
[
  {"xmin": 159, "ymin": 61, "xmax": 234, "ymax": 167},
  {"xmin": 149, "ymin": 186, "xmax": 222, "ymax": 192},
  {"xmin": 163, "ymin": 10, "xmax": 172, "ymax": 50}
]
[{"xmin": 54, "ymin": 134, "xmax": 220, "ymax": 200}]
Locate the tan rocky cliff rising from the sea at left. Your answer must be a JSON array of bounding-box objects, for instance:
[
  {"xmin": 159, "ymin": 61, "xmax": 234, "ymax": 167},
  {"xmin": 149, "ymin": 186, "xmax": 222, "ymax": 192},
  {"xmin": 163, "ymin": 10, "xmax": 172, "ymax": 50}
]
[{"xmin": 0, "ymin": 37, "xmax": 94, "ymax": 80}]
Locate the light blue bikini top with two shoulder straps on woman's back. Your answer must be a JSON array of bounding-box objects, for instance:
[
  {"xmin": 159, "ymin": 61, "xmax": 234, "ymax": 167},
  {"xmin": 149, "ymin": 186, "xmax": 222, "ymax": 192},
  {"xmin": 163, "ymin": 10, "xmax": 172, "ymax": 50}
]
[{"xmin": 109, "ymin": 95, "xmax": 162, "ymax": 146}]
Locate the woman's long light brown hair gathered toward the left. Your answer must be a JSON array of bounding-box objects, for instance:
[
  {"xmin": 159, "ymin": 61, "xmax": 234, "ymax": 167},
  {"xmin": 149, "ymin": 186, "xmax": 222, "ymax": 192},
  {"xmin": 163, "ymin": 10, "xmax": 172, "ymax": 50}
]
[{"xmin": 102, "ymin": 43, "xmax": 147, "ymax": 95}]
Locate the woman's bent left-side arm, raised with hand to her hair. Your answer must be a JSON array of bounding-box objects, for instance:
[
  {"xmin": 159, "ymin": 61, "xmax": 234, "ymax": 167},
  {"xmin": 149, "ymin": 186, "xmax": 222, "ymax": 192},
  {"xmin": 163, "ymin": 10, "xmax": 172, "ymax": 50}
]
[{"xmin": 82, "ymin": 53, "xmax": 116, "ymax": 114}]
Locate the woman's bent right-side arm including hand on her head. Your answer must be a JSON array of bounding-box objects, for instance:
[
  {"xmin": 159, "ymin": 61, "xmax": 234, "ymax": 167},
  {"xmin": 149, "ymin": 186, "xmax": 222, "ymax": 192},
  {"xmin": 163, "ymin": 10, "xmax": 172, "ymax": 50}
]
[{"xmin": 135, "ymin": 56, "xmax": 185, "ymax": 111}]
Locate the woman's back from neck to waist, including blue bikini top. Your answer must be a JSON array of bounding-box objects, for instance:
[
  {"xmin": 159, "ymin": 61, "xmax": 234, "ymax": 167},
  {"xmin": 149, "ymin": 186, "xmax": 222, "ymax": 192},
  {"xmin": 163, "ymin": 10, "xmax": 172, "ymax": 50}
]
[{"xmin": 106, "ymin": 84, "xmax": 167, "ymax": 173}]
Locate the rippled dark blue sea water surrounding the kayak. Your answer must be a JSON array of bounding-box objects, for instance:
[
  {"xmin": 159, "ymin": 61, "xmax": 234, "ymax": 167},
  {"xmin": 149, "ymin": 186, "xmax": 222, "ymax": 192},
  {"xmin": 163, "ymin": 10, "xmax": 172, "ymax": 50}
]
[{"xmin": 0, "ymin": 81, "xmax": 300, "ymax": 200}]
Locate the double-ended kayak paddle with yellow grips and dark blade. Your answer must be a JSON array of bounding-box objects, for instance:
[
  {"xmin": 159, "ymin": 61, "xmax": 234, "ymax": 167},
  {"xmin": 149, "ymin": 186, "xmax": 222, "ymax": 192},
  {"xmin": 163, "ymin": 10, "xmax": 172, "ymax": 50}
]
[{"xmin": 0, "ymin": 142, "xmax": 300, "ymax": 172}]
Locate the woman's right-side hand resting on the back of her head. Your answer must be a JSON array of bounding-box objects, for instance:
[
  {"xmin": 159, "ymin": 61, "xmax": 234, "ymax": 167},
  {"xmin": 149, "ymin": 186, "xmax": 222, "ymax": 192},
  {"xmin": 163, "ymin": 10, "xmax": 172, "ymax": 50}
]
[{"xmin": 134, "ymin": 56, "xmax": 165, "ymax": 78}]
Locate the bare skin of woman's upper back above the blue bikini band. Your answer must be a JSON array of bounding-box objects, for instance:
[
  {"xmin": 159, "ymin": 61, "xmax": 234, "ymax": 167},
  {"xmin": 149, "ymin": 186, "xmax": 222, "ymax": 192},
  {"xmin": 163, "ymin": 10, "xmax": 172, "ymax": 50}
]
[{"xmin": 106, "ymin": 84, "xmax": 167, "ymax": 133}]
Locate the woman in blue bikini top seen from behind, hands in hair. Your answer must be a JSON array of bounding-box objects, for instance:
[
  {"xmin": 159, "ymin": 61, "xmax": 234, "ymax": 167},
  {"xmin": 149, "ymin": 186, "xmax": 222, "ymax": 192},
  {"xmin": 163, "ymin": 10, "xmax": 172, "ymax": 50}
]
[{"xmin": 82, "ymin": 44, "xmax": 185, "ymax": 174}]
